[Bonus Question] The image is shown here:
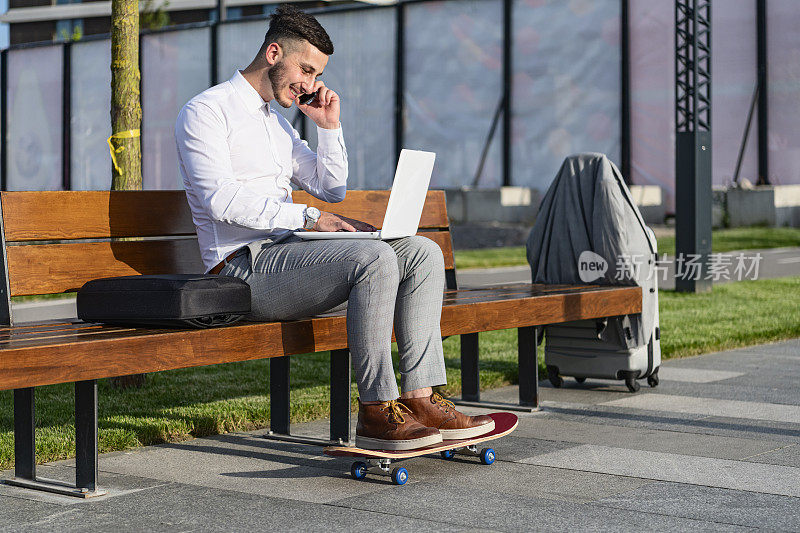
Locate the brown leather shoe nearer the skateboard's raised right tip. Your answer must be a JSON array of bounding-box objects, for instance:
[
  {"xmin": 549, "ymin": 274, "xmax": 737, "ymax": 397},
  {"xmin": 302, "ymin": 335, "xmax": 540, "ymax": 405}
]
[{"xmin": 401, "ymin": 392, "xmax": 494, "ymax": 440}]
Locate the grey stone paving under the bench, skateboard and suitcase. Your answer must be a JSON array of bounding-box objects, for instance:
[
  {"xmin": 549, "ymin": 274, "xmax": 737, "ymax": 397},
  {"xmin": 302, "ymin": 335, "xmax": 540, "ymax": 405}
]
[{"xmin": 0, "ymin": 339, "xmax": 800, "ymax": 531}]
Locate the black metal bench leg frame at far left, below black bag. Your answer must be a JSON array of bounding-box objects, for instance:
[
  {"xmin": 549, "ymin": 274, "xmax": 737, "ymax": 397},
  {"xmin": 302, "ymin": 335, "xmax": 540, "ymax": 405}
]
[{"xmin": 5, "ymin": 380, "xmax": 106, "ymax": 498}]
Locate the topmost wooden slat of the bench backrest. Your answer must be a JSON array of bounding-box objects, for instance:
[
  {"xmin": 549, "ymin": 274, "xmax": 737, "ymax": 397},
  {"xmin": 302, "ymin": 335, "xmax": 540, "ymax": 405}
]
[{"xmin": 0, "ymin": 191, "xmax": 449, "ymax": 242}]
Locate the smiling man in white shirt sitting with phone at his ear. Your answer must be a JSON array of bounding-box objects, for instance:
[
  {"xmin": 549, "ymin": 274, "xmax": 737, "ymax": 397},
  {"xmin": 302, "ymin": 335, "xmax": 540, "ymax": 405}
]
[{"xmin": 175, "ymin": 6, "xmax": 494, "ymax": 450}]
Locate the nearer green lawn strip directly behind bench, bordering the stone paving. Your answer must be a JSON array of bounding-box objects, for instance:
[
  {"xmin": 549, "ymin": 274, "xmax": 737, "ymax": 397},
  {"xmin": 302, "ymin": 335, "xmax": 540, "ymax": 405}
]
[{"xmin": 0, "ymin": 277, "xmax": 800, "ymax": 469}]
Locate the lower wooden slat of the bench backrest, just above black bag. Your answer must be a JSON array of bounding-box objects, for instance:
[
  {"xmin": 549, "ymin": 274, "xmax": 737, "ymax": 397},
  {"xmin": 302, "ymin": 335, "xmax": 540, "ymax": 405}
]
[{"xmin": 7, "ymin": 231, "xmax": 454, "ymax": 296}]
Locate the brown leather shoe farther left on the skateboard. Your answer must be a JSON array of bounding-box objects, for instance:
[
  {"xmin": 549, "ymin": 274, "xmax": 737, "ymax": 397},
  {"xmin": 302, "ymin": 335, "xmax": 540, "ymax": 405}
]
[{"xmin": 356, "ymin": 400, "xmax": 442, "ymax": 451}]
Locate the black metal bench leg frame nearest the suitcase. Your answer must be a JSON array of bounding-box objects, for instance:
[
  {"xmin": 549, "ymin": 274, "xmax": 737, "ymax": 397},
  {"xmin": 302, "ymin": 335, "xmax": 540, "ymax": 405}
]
[{"xmin": 450, "ymin": 327, "xmax": 539, "ymax": 413}]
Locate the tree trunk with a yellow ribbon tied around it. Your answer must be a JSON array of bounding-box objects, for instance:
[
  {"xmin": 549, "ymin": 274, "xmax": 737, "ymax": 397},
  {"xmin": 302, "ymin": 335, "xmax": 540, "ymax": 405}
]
[{"xmin": 109, "ymin": 0, "xmax": 145, "ymax": 389}]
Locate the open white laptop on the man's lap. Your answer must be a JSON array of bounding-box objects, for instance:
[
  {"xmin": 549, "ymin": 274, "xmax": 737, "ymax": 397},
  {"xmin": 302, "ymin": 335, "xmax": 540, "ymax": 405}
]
[{"xmin": 294, "ymin": 150, "xmax": 436, "ymax": 240}]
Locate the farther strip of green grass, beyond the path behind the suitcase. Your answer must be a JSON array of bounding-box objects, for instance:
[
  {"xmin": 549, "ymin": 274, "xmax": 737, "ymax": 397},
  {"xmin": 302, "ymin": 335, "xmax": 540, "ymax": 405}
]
[{"xmin": 455, "ymin": 227, "xmax": 800, "ymax": 269}]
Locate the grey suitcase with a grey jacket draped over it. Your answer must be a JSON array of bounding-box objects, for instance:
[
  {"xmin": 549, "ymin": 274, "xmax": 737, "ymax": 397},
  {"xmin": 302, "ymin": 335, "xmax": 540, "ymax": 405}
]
[{"xmin": 527, "ymin": 153, "xmax": 661, "ymax": 391}]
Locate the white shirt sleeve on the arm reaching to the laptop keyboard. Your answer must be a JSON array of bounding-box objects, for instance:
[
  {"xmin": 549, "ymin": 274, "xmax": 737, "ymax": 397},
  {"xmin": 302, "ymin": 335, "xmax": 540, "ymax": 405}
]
[{"xmin": 175, "ymin": 102, "xmax": 308, "ymax": 231}]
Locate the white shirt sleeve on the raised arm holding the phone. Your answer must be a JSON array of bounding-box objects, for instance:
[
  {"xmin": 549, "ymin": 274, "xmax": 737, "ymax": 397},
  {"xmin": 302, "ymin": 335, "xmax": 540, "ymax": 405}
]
[{"xmin": 292, "ymin": 125, "xmax": 348, "ymax": 202}]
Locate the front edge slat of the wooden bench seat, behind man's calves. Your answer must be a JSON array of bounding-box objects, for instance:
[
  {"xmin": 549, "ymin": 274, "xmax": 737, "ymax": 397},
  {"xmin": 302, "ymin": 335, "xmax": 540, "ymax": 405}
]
[{"xmin": 0, "ymin": 286, "xmax": 642, "ymax": 390}]
